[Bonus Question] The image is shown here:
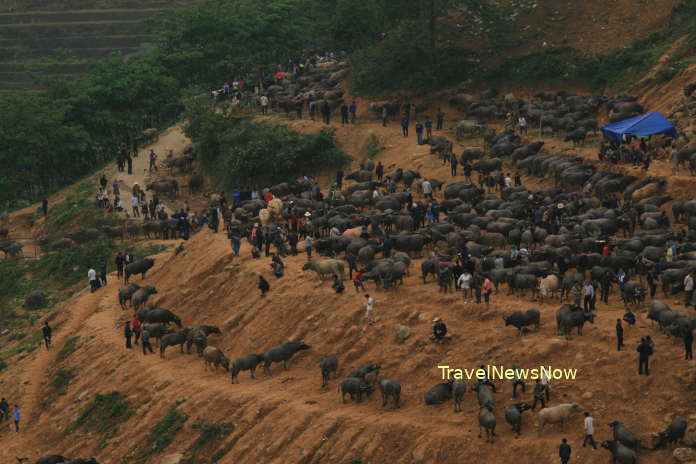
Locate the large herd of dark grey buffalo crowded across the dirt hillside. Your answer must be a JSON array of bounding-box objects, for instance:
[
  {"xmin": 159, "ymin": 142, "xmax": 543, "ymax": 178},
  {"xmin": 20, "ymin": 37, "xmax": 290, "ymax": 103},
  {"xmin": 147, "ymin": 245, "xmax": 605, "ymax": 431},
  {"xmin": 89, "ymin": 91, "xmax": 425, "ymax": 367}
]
[{"xmin": 102, "ymin": 88, "xmax": 696, "ymax": 464}]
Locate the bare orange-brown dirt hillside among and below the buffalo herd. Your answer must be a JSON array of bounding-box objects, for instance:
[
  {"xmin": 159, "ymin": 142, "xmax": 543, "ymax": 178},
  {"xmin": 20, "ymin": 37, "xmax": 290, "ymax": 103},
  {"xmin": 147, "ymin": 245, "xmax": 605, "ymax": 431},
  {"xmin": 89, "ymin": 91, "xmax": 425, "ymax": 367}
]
[{"xmin": 0, "ymin": 84, "xmax": 696, "ymax": 464}]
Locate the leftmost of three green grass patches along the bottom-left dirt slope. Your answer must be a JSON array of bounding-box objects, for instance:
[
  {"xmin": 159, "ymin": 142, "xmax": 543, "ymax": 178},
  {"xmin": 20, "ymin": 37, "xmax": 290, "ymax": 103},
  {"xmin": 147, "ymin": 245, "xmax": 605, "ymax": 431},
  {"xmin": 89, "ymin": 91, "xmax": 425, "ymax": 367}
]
[{"xmin": 66, "ymin": 391, "xmax": 134, "ymax": 436}]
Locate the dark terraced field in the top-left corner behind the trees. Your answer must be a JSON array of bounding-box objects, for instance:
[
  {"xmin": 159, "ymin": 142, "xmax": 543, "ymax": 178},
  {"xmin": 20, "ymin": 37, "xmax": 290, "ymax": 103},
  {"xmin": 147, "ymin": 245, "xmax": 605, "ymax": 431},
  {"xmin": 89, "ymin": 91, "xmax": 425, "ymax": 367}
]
[{"xmin": 0, "ymin": 0, "xmax": 194, "ymax": 91}]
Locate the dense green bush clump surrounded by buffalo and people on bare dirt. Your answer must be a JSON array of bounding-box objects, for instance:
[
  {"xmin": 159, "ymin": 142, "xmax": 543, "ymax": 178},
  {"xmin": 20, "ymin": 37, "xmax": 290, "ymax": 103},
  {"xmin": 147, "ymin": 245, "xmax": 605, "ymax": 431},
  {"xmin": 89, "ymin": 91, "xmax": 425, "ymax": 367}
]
[{"xmin": 186, "ymin": 99, "xmax": 349, "ymax": 189}]
